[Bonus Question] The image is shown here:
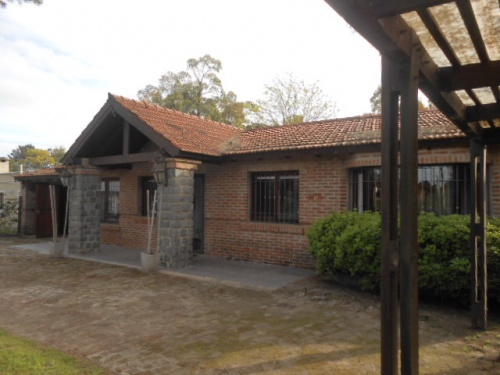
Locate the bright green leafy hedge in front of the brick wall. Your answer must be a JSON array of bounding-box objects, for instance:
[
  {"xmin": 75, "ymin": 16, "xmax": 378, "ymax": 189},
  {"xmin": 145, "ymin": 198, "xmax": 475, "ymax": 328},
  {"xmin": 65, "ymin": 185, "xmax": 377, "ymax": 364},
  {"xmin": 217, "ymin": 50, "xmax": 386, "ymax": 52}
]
[{"xmin": 307, "ymin": 212, "xmax": 500, "ymax": 305}]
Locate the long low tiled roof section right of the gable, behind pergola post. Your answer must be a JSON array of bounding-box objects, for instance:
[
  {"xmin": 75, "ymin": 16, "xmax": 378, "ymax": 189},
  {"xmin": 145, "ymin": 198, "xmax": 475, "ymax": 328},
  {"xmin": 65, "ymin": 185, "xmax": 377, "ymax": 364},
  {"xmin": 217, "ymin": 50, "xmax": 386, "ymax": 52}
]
[{"xmin": 220, "ymin": 109, "xmax": 465, "ymax": 154}]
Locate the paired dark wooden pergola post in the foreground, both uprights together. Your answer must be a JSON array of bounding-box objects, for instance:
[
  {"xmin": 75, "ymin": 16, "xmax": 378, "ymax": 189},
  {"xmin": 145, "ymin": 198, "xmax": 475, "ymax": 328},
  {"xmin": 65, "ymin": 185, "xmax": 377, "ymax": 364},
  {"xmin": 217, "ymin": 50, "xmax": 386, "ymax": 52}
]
[{"xmin": 381, "ymin": 39, "xmax": 419, "ymax": 374}]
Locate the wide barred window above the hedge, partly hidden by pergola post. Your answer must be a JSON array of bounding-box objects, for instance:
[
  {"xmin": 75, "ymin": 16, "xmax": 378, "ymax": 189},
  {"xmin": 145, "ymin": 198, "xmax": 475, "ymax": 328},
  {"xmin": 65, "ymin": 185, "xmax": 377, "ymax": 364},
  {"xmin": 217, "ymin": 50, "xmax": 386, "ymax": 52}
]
[{"xmin": 349, "ymin": 164, "xmax": 470, "ymax": 215}]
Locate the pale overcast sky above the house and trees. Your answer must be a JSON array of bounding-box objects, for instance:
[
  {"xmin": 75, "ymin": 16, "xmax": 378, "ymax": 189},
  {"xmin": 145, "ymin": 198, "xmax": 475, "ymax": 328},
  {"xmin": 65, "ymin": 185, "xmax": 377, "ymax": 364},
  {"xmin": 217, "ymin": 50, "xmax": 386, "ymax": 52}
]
[{"xmin": 0, "ymin": 0, "xmax": 380, "ymax": 157}]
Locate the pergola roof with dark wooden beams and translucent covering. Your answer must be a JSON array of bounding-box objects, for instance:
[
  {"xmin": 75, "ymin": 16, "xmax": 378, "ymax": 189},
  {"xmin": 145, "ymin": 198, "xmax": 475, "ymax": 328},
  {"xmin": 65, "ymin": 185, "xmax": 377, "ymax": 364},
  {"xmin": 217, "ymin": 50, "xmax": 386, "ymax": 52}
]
[{"xmin": 325, "ymin": 0, "xmax": 500, "ymax": 143}]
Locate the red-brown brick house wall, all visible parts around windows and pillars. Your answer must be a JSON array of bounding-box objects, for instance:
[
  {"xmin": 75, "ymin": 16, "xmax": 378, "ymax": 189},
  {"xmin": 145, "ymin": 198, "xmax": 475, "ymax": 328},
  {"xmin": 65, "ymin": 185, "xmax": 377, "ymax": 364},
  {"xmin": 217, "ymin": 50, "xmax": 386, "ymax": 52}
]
[{"xmin": 95, "ymin": 147, "xmax": 500, "ymax": 268}]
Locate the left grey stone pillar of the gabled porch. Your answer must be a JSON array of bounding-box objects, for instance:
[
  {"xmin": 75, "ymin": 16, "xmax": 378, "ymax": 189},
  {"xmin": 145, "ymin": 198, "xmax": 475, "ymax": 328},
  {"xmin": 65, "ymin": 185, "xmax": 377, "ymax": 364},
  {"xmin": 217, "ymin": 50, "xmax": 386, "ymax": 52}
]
[{"xmin": 68, "ymin": 166, "xmax": 101, "ymax": 254}]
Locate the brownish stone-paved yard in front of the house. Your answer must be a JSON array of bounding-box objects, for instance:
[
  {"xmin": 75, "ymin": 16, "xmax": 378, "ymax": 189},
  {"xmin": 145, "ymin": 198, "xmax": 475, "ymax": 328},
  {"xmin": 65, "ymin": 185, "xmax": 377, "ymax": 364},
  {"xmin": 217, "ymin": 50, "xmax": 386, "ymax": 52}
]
[{"xmin": 0, "ymin": 240, "xmax": 500, "ymax": 375}]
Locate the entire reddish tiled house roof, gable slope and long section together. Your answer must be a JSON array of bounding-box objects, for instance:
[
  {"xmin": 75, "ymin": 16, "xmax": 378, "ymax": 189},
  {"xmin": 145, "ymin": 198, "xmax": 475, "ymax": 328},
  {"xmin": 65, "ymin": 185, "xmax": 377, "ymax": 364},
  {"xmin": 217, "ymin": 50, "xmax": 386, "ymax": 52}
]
[{"xmin": 110, "ymin": 94, "xmax": 465, "ymax": 156}]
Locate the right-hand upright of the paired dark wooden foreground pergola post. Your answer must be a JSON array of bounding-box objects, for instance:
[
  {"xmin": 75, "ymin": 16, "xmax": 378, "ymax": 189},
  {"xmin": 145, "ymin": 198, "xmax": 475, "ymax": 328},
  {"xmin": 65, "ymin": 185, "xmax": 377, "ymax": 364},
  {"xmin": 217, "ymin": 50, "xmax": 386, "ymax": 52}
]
[{"xmin": 399, "ymin": 39, "xmax": 420, "ymax": 375}]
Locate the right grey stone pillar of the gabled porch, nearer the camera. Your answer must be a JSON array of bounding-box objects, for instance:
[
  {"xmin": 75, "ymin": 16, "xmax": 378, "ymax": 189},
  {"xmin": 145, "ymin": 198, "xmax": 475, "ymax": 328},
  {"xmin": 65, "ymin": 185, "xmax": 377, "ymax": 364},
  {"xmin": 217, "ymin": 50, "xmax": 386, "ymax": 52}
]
[{"xmin": 159, "ymin": 159, "xmax": 200, "ymax": 268}]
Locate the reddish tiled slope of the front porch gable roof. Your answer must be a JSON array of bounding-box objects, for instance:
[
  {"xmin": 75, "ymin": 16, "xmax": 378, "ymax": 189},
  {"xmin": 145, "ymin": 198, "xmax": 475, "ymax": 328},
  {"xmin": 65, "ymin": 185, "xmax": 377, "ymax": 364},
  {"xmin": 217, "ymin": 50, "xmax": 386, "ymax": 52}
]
[{"xmin": 110, "ymin": 95, "xmax": 242, "ymax": 156}]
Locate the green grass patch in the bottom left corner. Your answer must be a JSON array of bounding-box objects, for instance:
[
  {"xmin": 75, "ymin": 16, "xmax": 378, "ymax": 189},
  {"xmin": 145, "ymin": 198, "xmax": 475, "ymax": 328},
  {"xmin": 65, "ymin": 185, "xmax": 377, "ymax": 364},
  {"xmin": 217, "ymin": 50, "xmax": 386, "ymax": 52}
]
[{"xmin": 0, "ymin": 329, "xmax": 108, "ymax": 375}]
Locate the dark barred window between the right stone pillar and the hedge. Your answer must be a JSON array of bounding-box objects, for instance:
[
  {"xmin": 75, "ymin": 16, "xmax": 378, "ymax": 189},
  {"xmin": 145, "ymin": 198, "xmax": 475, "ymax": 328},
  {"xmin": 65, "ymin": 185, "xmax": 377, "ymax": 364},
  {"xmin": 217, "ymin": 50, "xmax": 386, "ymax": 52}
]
[{"xmin": 250, "ymin": 171, "xmax": 299, "ymax": 224}]
